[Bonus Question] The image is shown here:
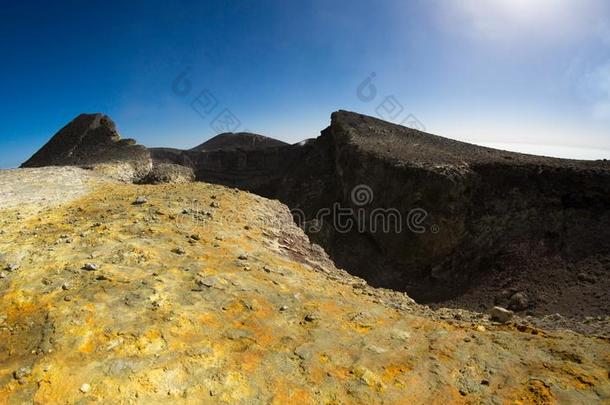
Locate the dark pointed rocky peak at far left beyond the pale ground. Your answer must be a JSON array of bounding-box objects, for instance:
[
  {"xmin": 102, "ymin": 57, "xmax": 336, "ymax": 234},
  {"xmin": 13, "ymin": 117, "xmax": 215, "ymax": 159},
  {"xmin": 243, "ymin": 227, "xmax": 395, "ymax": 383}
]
[{"xmin": 21, "ymin": 113, "xmax": 152, "ymax": 180}]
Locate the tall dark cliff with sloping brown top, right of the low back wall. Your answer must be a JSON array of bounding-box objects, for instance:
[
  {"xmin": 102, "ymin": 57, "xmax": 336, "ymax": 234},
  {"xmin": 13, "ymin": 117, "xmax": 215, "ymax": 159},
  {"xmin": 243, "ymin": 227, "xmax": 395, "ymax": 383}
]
[{"xmin": 314, "ymin": 112, "xmax": 610, "ymax": 301}]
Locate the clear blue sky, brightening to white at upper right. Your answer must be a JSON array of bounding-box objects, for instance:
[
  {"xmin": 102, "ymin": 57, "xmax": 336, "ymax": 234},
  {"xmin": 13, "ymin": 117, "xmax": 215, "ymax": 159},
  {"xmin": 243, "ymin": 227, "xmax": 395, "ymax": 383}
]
[{"xmin": 0, "ymin": 0, "xmax": 610, "ymax": 167}]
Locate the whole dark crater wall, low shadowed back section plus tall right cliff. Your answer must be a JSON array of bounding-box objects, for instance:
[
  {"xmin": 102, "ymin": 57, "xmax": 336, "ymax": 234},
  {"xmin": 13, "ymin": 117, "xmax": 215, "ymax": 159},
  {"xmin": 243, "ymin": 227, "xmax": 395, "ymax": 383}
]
[{"xmin": 148, "ymin": 111, "xmax": 610, "ymax": 315}]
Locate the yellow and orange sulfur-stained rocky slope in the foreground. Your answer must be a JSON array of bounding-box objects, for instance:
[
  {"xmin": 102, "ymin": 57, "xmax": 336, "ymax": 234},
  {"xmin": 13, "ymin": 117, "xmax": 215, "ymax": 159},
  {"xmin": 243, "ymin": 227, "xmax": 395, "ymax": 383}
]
[{"xmin": 0, "ymin": 169, "xmax": 610, "ymax": 404}]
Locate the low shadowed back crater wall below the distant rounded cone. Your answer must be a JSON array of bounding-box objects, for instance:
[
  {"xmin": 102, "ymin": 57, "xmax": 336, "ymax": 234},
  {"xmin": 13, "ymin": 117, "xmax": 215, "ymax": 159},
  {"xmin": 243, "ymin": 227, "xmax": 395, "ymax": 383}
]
[{"xmin": 150, "ymin": 131, "xmax": 335, "ymax": 207}]
